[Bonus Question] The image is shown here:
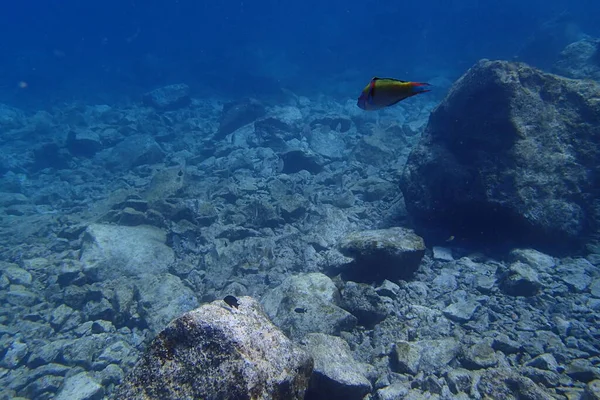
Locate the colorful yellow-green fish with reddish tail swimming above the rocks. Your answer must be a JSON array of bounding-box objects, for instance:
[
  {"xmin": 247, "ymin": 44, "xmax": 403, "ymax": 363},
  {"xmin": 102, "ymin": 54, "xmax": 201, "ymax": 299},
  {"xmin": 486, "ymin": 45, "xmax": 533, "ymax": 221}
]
[{"xmin": 357, "ymin": 77, "xmax": 431, "ymax": 111}]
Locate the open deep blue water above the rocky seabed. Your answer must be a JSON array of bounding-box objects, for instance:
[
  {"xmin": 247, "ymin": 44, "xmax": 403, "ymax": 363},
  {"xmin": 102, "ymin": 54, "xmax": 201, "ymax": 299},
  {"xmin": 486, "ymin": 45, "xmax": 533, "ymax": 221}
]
[{"xmin": 0, "ymin": 0, "xmax": 600, "ymax": 104}]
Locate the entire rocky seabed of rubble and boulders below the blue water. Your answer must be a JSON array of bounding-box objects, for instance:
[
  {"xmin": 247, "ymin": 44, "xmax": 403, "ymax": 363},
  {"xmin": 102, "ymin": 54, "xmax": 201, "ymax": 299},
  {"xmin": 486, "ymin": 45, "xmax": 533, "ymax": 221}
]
[{"xmin": 0, "ymin": 55, "xmax": 600, "ymax": 400}]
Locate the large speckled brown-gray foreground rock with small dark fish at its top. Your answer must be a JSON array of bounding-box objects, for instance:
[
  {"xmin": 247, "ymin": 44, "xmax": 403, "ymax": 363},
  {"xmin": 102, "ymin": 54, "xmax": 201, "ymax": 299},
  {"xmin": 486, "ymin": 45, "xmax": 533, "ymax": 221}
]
[{"xmin": 115, "ymin": 297, "xmax": 313, "ymax": 400}]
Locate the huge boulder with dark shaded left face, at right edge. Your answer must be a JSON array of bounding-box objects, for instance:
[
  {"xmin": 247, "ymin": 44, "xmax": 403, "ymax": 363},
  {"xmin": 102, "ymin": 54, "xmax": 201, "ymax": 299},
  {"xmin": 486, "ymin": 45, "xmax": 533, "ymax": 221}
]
[{"xmin": 401, "ymin": 60, "xmax": 600, "ymax": 250}]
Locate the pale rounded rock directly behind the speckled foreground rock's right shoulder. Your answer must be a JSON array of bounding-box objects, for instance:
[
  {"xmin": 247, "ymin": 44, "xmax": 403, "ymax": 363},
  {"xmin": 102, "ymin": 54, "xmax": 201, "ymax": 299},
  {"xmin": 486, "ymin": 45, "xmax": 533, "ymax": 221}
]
[{"xmin": 261, "ymin": 273, "xmax": 357, "ymax": 339}]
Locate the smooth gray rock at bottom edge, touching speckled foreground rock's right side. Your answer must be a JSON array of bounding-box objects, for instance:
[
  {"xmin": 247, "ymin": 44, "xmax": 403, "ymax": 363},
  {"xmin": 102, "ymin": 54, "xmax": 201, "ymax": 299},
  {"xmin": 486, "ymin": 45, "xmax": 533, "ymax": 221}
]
[{"xmin": 302, "ymin": 333, "xmax": 371, "ymax": 400}]
